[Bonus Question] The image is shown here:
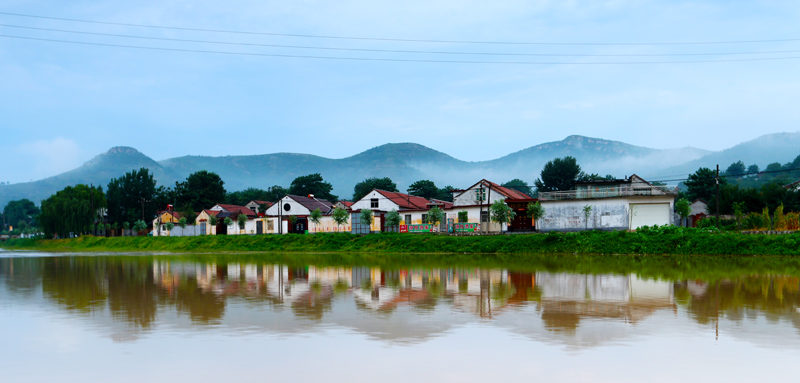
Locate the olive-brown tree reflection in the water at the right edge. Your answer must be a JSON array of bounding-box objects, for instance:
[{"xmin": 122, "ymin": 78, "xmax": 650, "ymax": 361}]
[{"xmin": 675, "ymin": 276, "xmax": 800, "ymax": 324}]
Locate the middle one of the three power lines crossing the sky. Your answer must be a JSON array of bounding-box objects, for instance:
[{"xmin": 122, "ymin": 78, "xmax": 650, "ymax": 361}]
[{"xmin": 0, "ymin": 24, "xmax": 800, "ymax": 57}]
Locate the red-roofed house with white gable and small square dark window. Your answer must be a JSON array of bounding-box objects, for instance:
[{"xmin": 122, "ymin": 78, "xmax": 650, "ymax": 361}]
[{"xmin": 350, "ymin": 189, "xmax": 434, "ymax": 234}]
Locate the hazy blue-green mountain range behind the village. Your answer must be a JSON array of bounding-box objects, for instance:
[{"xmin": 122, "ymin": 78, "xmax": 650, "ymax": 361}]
[{"xmin": 0, "ymin": 132, "xmax": 800, "ymax": 206}]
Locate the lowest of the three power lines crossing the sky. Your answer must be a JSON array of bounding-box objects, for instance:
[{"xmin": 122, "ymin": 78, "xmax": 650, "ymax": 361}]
[{"xmin": 0, "ymin": 34, "xmax": 800, "ymax": 65}]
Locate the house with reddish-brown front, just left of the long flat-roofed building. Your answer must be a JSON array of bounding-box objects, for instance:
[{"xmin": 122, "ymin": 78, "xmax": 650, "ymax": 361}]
[{"xmin": 447, "ymin": 179, "xmax": 536, "ymax": 231}]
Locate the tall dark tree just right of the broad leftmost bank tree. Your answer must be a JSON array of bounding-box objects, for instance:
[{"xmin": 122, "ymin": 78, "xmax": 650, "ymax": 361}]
[{"xmin": 106, "ymin": 168, "xmax": 164, "ymax": 222}]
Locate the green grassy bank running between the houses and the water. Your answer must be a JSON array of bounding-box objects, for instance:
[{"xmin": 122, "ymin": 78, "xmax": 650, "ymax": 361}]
[{"xmin": 0, "ymin": 226, "xmax": 800, "ymax": 256}]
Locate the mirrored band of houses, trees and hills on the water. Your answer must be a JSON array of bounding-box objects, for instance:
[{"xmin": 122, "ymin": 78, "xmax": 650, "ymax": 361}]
[{"xmin": 0, "ymin": 256, "xmax": 800, "ymax": 346}]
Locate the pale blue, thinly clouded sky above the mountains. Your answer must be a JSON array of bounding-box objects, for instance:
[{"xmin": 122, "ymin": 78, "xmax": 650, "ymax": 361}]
[{"xmin": 0, "ymin": 0, "xmax": 800, "ymax": 183}]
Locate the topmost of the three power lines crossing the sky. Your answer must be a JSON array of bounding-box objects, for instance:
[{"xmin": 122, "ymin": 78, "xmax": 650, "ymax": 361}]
[{"xmin": 0, "ymin": 12, "xmax": 800, "ymax": 46}]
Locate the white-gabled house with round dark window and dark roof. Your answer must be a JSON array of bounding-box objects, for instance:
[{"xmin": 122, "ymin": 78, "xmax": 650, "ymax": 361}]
[{"xmin": 264, "ymin": 195, "xmax": 338, "ymax": 234}]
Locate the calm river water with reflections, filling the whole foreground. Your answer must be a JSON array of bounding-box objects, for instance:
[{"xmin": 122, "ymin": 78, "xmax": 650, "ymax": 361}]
[{"xmin": 0, "ymin": 251, "xmax": 800, "ymax": 383}]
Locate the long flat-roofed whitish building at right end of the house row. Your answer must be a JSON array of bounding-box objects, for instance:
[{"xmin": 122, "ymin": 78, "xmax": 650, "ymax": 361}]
[{"xmin": 539, "ymin": 175, "xmax": 675, "ymax": 231}]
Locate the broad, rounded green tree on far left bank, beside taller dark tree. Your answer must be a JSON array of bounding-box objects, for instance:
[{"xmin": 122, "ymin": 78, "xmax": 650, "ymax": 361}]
[{"xmin": 39, "ymin": 184, "xmax": 106, "ymax": 238}]
